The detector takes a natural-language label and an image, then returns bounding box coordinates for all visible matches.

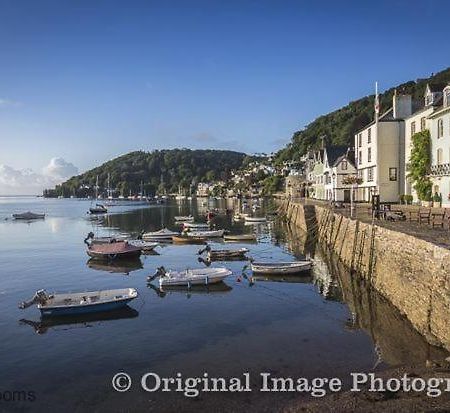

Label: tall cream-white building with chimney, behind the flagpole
[355,93,412,202]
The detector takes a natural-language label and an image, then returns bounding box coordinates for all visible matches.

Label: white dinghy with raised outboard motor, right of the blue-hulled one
[148,267,232,288]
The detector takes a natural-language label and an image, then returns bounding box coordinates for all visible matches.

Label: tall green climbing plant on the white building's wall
[408,130,432,201]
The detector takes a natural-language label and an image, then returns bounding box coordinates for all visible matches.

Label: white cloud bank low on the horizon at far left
[0,158,78,195]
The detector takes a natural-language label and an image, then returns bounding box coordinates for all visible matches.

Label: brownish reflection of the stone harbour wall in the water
[278,220,448,368]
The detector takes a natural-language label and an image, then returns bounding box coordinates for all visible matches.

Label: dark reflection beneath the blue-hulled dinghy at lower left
[20,306,139,334]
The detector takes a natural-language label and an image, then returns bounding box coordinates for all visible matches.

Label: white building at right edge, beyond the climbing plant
[429,85,450,207]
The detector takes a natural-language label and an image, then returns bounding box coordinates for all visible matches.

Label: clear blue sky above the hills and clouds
[0,0,450,193]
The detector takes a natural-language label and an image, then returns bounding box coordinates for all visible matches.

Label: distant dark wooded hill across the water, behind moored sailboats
[44,149,249,197]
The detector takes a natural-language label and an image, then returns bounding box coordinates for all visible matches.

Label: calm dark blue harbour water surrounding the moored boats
[0,198,443,412]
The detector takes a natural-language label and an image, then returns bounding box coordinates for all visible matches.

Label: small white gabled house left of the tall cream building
[323,146,357,202]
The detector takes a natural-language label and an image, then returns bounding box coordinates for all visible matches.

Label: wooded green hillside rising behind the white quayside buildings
[277,68,450,162]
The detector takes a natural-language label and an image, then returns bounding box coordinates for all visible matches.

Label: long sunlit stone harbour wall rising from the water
[280,201,450,350]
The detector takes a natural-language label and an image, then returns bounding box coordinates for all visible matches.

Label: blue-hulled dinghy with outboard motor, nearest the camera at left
[19,288,138,316]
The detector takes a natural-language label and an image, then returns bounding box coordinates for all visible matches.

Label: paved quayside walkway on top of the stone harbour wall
[292,199,450,249]
